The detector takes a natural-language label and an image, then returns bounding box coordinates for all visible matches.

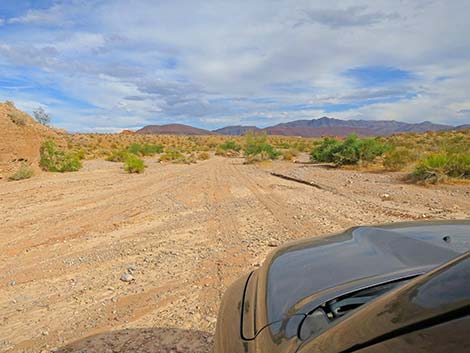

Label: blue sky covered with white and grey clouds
[0,0,470,132]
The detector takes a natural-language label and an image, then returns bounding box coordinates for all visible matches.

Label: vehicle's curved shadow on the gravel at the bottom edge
[56,328,213,353]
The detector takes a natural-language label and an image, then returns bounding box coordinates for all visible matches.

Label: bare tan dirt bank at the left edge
[0,103,61,179]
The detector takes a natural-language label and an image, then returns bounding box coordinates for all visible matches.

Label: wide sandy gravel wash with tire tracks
[0,157,470,353]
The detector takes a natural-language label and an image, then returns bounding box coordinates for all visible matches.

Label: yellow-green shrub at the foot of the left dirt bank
[39,140,82,173]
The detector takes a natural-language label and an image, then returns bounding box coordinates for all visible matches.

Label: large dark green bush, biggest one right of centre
[311,134,390,165]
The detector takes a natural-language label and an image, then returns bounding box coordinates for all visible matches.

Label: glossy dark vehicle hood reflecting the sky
[252,221,470,336]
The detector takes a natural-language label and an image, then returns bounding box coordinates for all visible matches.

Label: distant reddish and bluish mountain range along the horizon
[137,117,470,137]
